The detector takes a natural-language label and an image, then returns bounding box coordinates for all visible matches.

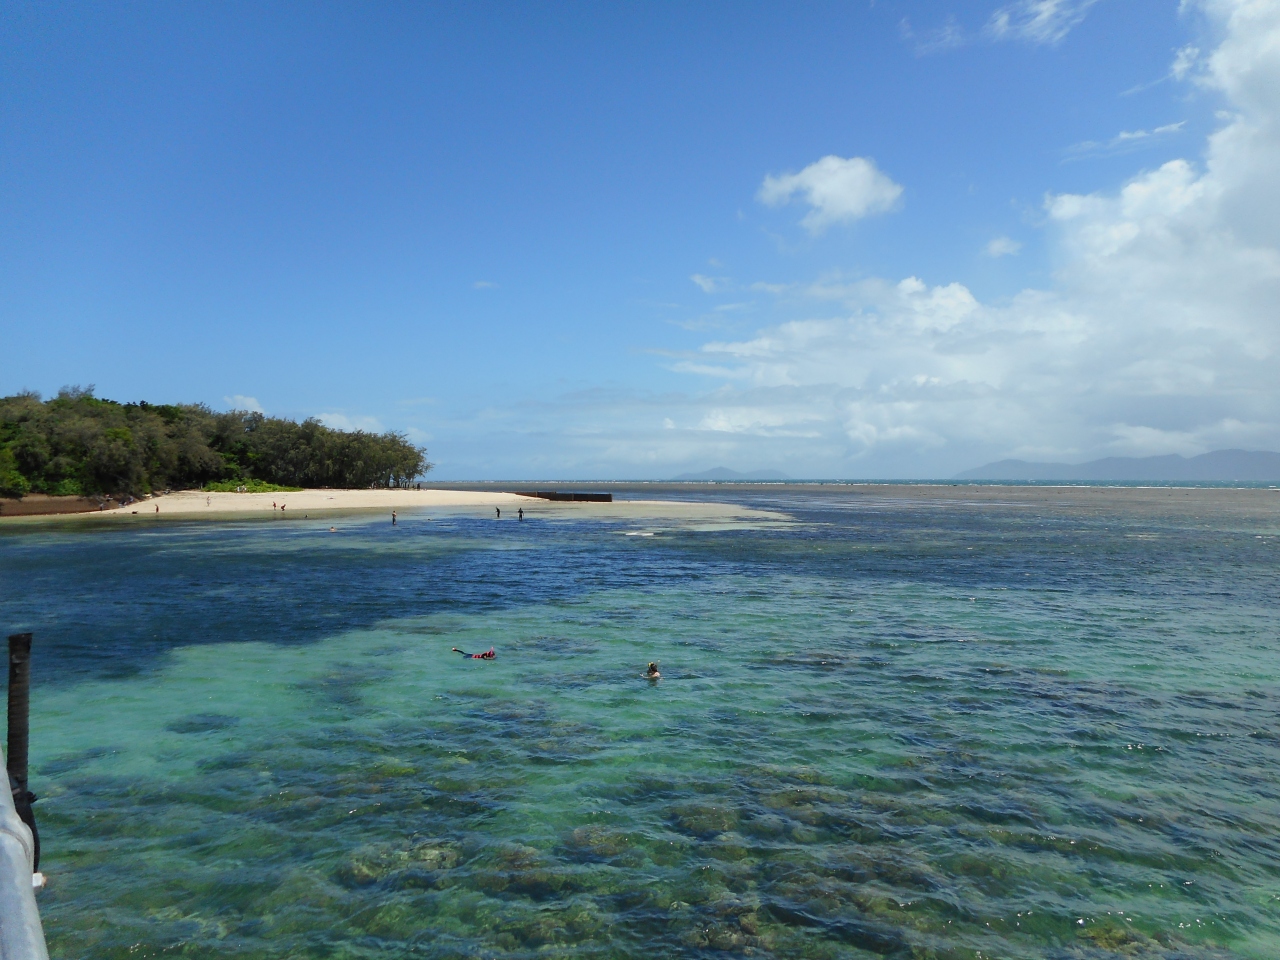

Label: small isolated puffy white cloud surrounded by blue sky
[759,156,902,234]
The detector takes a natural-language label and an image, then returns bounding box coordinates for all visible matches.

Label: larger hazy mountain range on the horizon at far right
[955,451,1280,483]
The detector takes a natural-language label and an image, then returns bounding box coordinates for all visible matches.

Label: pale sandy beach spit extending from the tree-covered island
[0,489,788,526]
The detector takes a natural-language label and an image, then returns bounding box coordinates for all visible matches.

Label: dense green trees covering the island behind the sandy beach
[0,387,431,497]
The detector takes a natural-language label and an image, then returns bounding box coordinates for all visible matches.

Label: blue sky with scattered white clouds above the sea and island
[0,0,1280,479]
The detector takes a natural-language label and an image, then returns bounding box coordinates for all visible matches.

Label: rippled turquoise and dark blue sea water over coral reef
[0,492,1280,957]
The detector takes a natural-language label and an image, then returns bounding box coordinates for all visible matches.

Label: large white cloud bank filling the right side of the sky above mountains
[680,0,1280,474]
